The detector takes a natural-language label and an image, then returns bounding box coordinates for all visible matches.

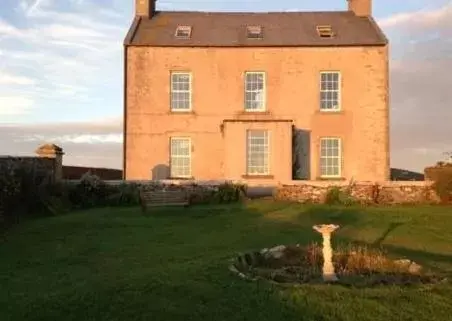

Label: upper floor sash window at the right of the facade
[320,71,341,111]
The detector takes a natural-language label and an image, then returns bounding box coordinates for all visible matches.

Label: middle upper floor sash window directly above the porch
[245,71,265,111]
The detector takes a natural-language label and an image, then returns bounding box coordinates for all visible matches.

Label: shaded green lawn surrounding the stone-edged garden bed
[0,201,452,321]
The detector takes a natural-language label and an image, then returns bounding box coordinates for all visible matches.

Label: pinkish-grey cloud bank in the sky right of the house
[379,3,452,170]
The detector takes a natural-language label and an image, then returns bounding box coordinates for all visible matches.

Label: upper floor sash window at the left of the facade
[171,72,191,112]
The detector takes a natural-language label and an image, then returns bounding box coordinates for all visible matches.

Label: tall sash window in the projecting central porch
[246,130,269,175]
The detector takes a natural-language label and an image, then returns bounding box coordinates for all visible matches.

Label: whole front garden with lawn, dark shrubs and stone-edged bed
[0,159,452,321]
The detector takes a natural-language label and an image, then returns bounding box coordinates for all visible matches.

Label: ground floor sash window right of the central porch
[320,137,341,177]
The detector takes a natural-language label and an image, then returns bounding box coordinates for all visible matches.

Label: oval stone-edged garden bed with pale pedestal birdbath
[229,225,447,287]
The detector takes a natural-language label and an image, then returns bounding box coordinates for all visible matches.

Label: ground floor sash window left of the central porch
[170,137,191,178]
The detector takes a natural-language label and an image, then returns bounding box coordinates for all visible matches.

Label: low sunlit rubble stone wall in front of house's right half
[274,181,439,205]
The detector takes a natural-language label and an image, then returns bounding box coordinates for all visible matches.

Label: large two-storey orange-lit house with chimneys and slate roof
[124,0,390,184]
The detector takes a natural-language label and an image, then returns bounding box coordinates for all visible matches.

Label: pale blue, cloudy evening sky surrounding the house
[0,0,452,171]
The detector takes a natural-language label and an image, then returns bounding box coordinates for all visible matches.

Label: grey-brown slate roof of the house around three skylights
[124,11,388,47]
